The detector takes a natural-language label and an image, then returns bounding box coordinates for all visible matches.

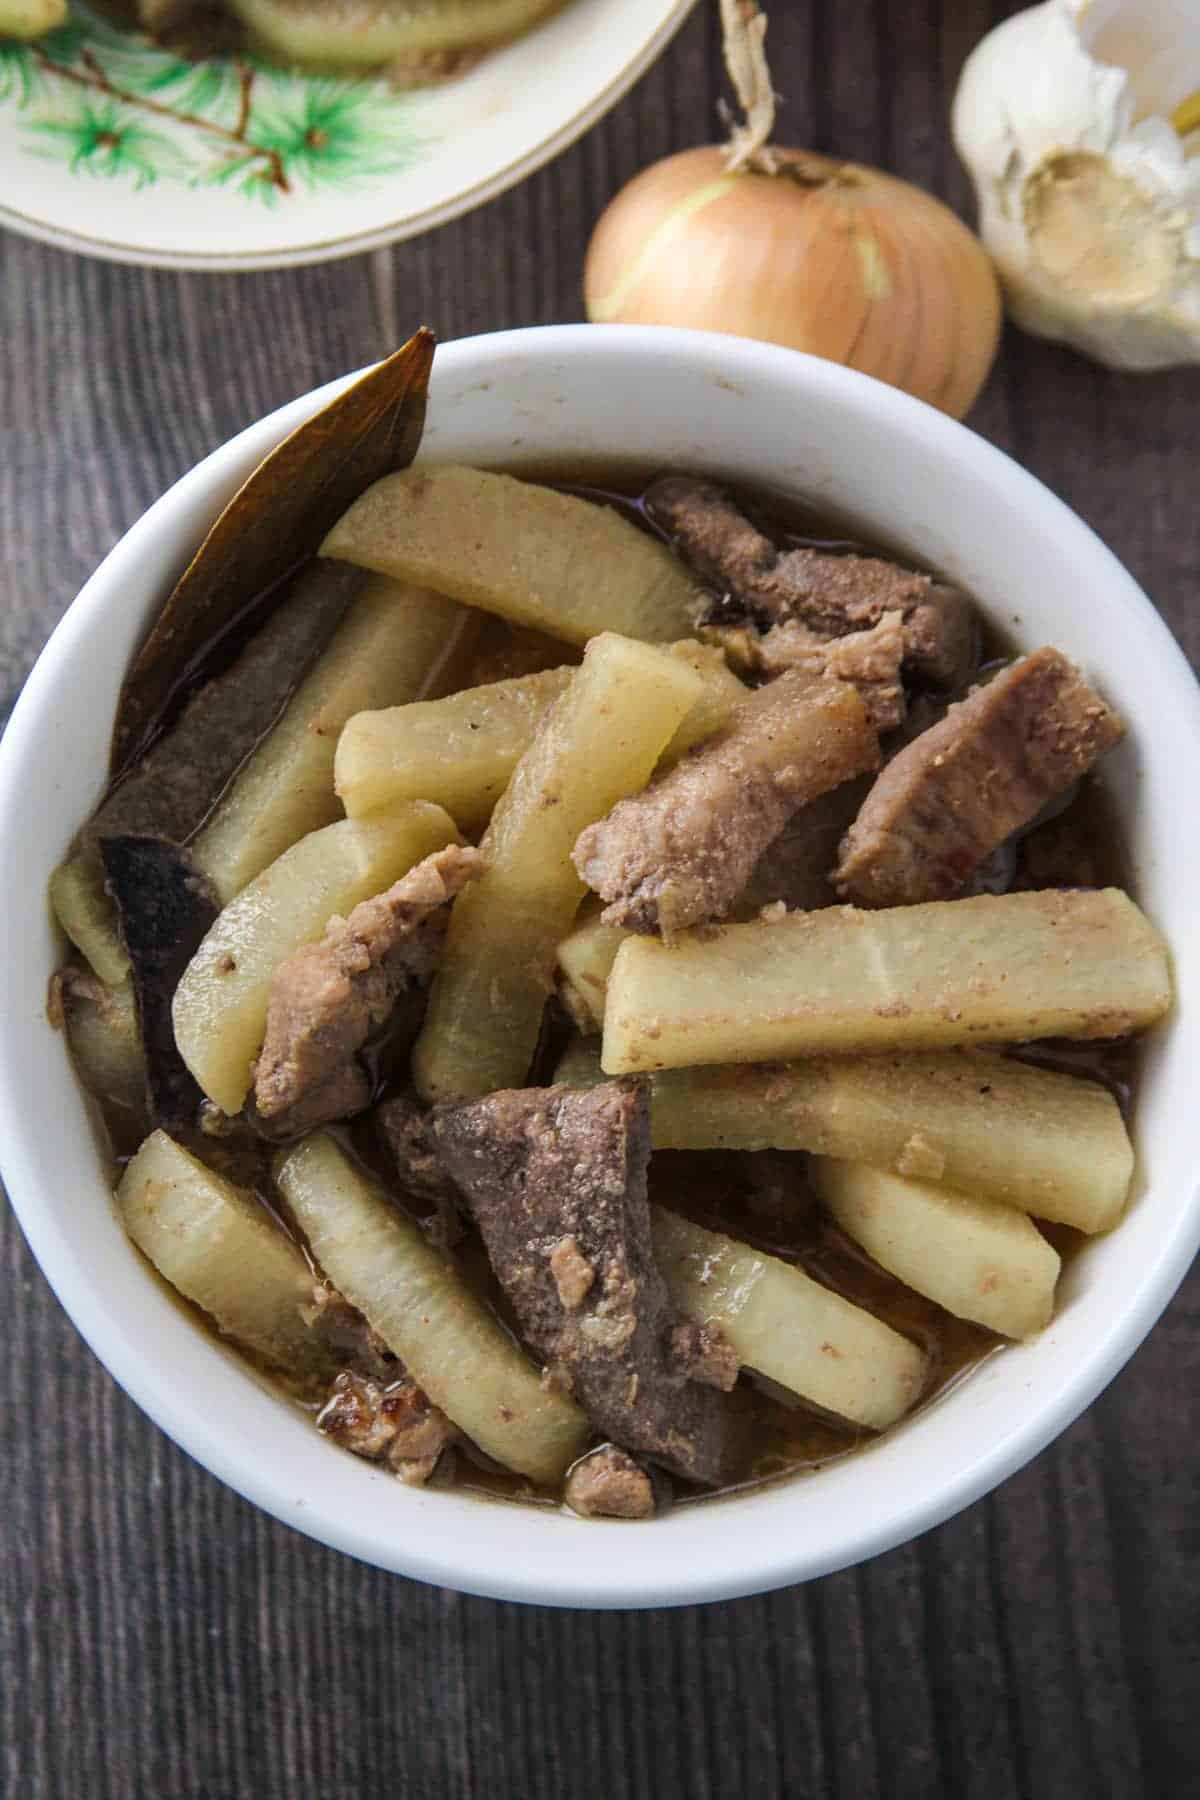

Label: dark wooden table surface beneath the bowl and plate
[0,0,1200,1800]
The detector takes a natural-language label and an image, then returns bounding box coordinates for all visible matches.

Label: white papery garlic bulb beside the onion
[954,0,1200,369]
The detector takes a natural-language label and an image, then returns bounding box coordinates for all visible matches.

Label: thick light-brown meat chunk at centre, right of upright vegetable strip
[574,670,880,938]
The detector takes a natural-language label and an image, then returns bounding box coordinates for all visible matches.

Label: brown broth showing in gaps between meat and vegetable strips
[75,466,1139,1507]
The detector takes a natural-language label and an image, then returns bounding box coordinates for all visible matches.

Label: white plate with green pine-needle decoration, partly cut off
[0,0,694,270]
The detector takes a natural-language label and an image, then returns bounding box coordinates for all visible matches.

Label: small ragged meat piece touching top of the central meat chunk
[703,612,907,731]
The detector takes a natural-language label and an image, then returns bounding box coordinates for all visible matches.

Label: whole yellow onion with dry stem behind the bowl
[583,0,1000,418]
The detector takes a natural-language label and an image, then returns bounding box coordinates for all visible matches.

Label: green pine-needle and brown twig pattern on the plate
[0,5,428,207]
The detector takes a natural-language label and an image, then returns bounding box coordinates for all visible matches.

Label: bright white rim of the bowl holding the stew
[0,326,1200,1607]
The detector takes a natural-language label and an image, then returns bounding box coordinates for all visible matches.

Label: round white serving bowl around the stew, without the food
[0,326,1200,1606]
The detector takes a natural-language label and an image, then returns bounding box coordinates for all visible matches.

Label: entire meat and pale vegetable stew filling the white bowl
[50,342,1171,1528]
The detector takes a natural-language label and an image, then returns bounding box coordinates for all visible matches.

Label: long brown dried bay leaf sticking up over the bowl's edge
[113,328,435,769]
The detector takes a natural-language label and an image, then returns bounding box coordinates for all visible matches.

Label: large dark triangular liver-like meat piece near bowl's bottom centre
[435,1082,725,1483]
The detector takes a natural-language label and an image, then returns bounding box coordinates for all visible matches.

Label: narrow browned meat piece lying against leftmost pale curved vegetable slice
[254,844,484,1136]
